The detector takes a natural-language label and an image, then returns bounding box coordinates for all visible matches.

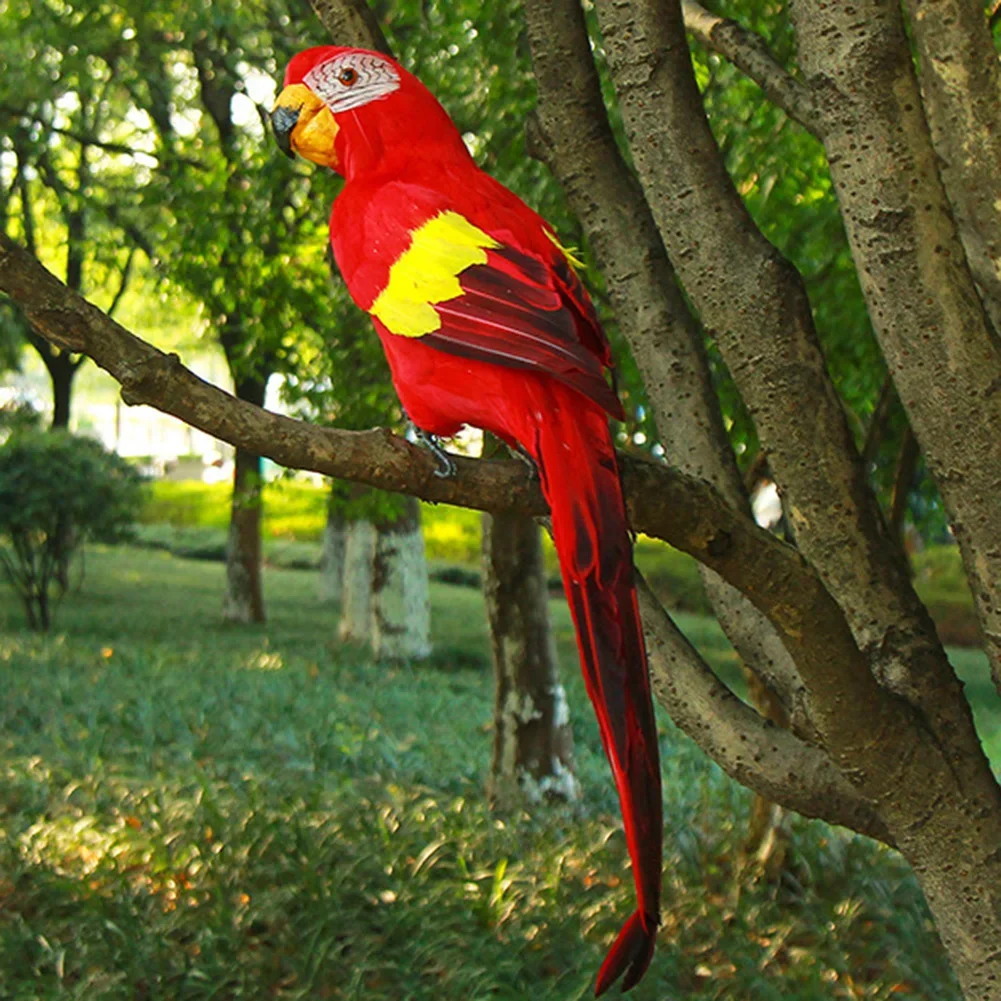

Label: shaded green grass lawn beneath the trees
[0,549,968,1001]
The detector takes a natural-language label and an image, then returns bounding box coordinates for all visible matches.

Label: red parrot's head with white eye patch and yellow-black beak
[271,45,468,177]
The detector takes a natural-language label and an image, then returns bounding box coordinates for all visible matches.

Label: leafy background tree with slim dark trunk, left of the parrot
[115,2,323,622]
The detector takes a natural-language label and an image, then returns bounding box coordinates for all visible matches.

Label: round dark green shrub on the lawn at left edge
[0,430,143,630]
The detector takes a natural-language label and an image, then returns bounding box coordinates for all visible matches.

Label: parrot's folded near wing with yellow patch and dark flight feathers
[344,185,624,420]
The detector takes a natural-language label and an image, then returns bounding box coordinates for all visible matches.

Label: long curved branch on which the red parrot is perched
[0,235,909,771]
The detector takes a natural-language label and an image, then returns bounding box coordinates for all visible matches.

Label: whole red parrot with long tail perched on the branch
[271,46,662,994]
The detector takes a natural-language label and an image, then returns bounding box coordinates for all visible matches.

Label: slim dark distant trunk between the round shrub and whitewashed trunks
[222,376,267,623]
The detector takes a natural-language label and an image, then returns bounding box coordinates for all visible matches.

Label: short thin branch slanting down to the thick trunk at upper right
[682,0,821,136]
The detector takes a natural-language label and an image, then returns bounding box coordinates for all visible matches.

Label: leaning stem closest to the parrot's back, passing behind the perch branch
[525,0,813,748]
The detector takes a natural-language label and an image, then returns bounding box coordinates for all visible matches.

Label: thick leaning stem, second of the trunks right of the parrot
[596,0,972,752]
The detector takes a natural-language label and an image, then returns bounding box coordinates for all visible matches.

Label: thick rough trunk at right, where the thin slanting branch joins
[792,2,1001,704]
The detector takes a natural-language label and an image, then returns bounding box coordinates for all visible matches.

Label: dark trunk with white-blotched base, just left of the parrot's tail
[483,514,580,809]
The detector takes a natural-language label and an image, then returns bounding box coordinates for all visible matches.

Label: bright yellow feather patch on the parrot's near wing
[368,211,501,337]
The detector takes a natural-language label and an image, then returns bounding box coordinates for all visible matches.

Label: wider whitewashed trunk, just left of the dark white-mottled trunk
[372,496,431,661]
